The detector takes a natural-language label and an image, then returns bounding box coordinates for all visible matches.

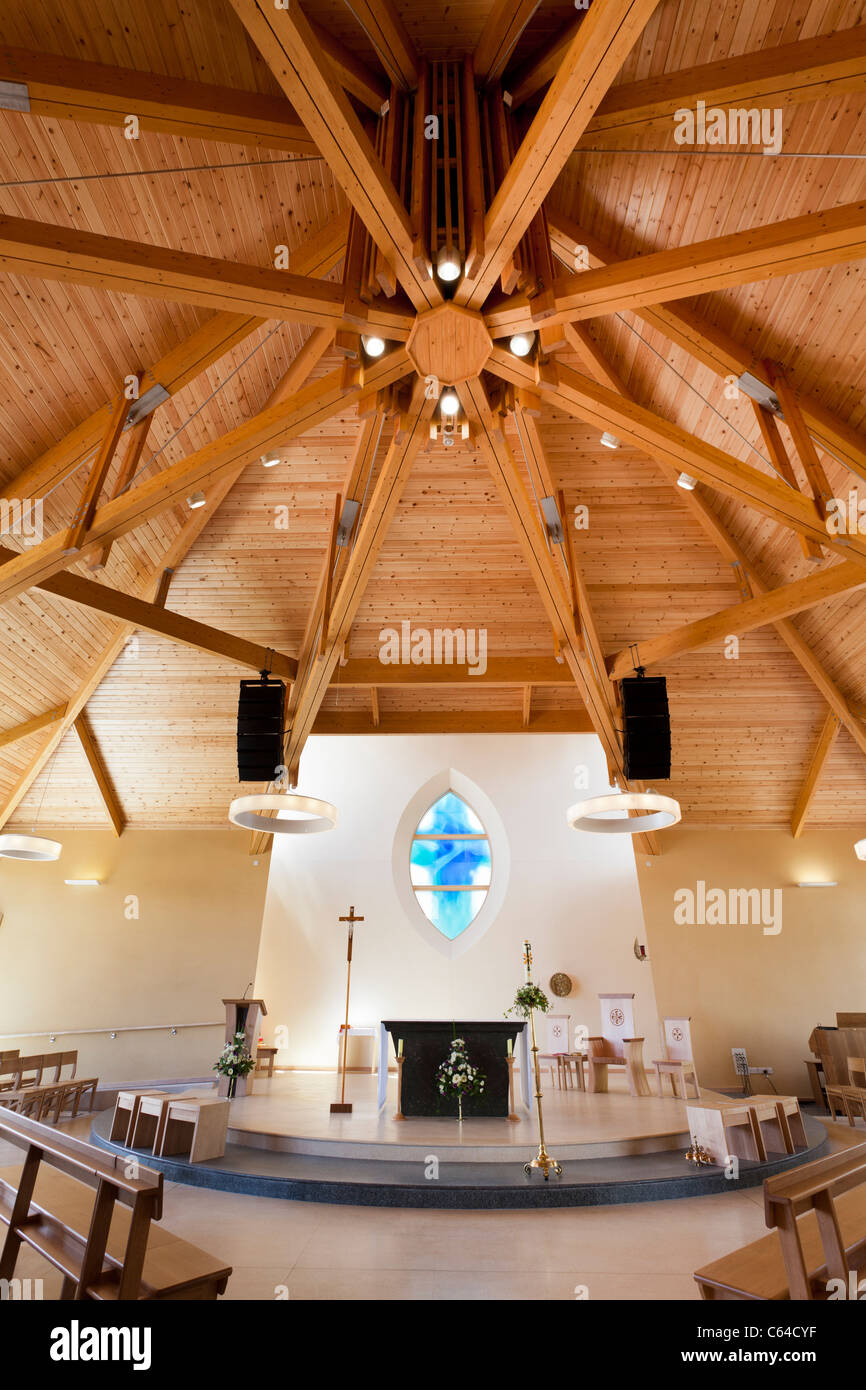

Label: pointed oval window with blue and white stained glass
[409,791,492,941]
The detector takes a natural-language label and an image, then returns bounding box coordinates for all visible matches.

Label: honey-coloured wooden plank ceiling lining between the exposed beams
[0,0,866,831]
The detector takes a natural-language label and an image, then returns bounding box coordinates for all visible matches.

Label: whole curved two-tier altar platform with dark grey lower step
[92,1072,827,1209]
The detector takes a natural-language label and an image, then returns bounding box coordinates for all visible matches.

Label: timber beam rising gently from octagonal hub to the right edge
[484,202,866,338]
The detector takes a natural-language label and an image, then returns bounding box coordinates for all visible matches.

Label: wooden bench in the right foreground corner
[695,1144,866,1301]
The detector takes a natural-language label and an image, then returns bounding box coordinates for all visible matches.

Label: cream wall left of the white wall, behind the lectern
[0,827,268,1081]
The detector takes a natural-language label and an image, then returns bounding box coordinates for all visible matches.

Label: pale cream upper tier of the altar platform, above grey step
[228,1072,697,1163]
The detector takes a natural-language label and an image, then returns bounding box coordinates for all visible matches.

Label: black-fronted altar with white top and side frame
[378,1019,532,1119]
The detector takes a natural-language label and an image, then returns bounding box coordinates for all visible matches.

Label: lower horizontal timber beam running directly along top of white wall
[311,709,594,733]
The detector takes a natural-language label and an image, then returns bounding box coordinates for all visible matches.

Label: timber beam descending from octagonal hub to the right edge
[487,348,866,560]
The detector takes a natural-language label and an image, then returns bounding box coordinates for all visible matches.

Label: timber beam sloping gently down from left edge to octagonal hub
[0,215,413,342]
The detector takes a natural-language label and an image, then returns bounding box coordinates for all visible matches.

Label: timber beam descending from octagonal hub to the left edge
[0,349,414,602]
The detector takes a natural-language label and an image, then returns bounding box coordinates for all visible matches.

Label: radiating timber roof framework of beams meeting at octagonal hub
[0,0,866,849]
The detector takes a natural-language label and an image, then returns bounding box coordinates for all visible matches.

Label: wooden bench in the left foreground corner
[0,1106,232,1301]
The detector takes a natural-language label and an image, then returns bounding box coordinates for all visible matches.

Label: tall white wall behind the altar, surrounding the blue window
[256,734,657,1066]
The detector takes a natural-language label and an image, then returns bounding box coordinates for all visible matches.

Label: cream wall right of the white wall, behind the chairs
[638,827,866,1095]
